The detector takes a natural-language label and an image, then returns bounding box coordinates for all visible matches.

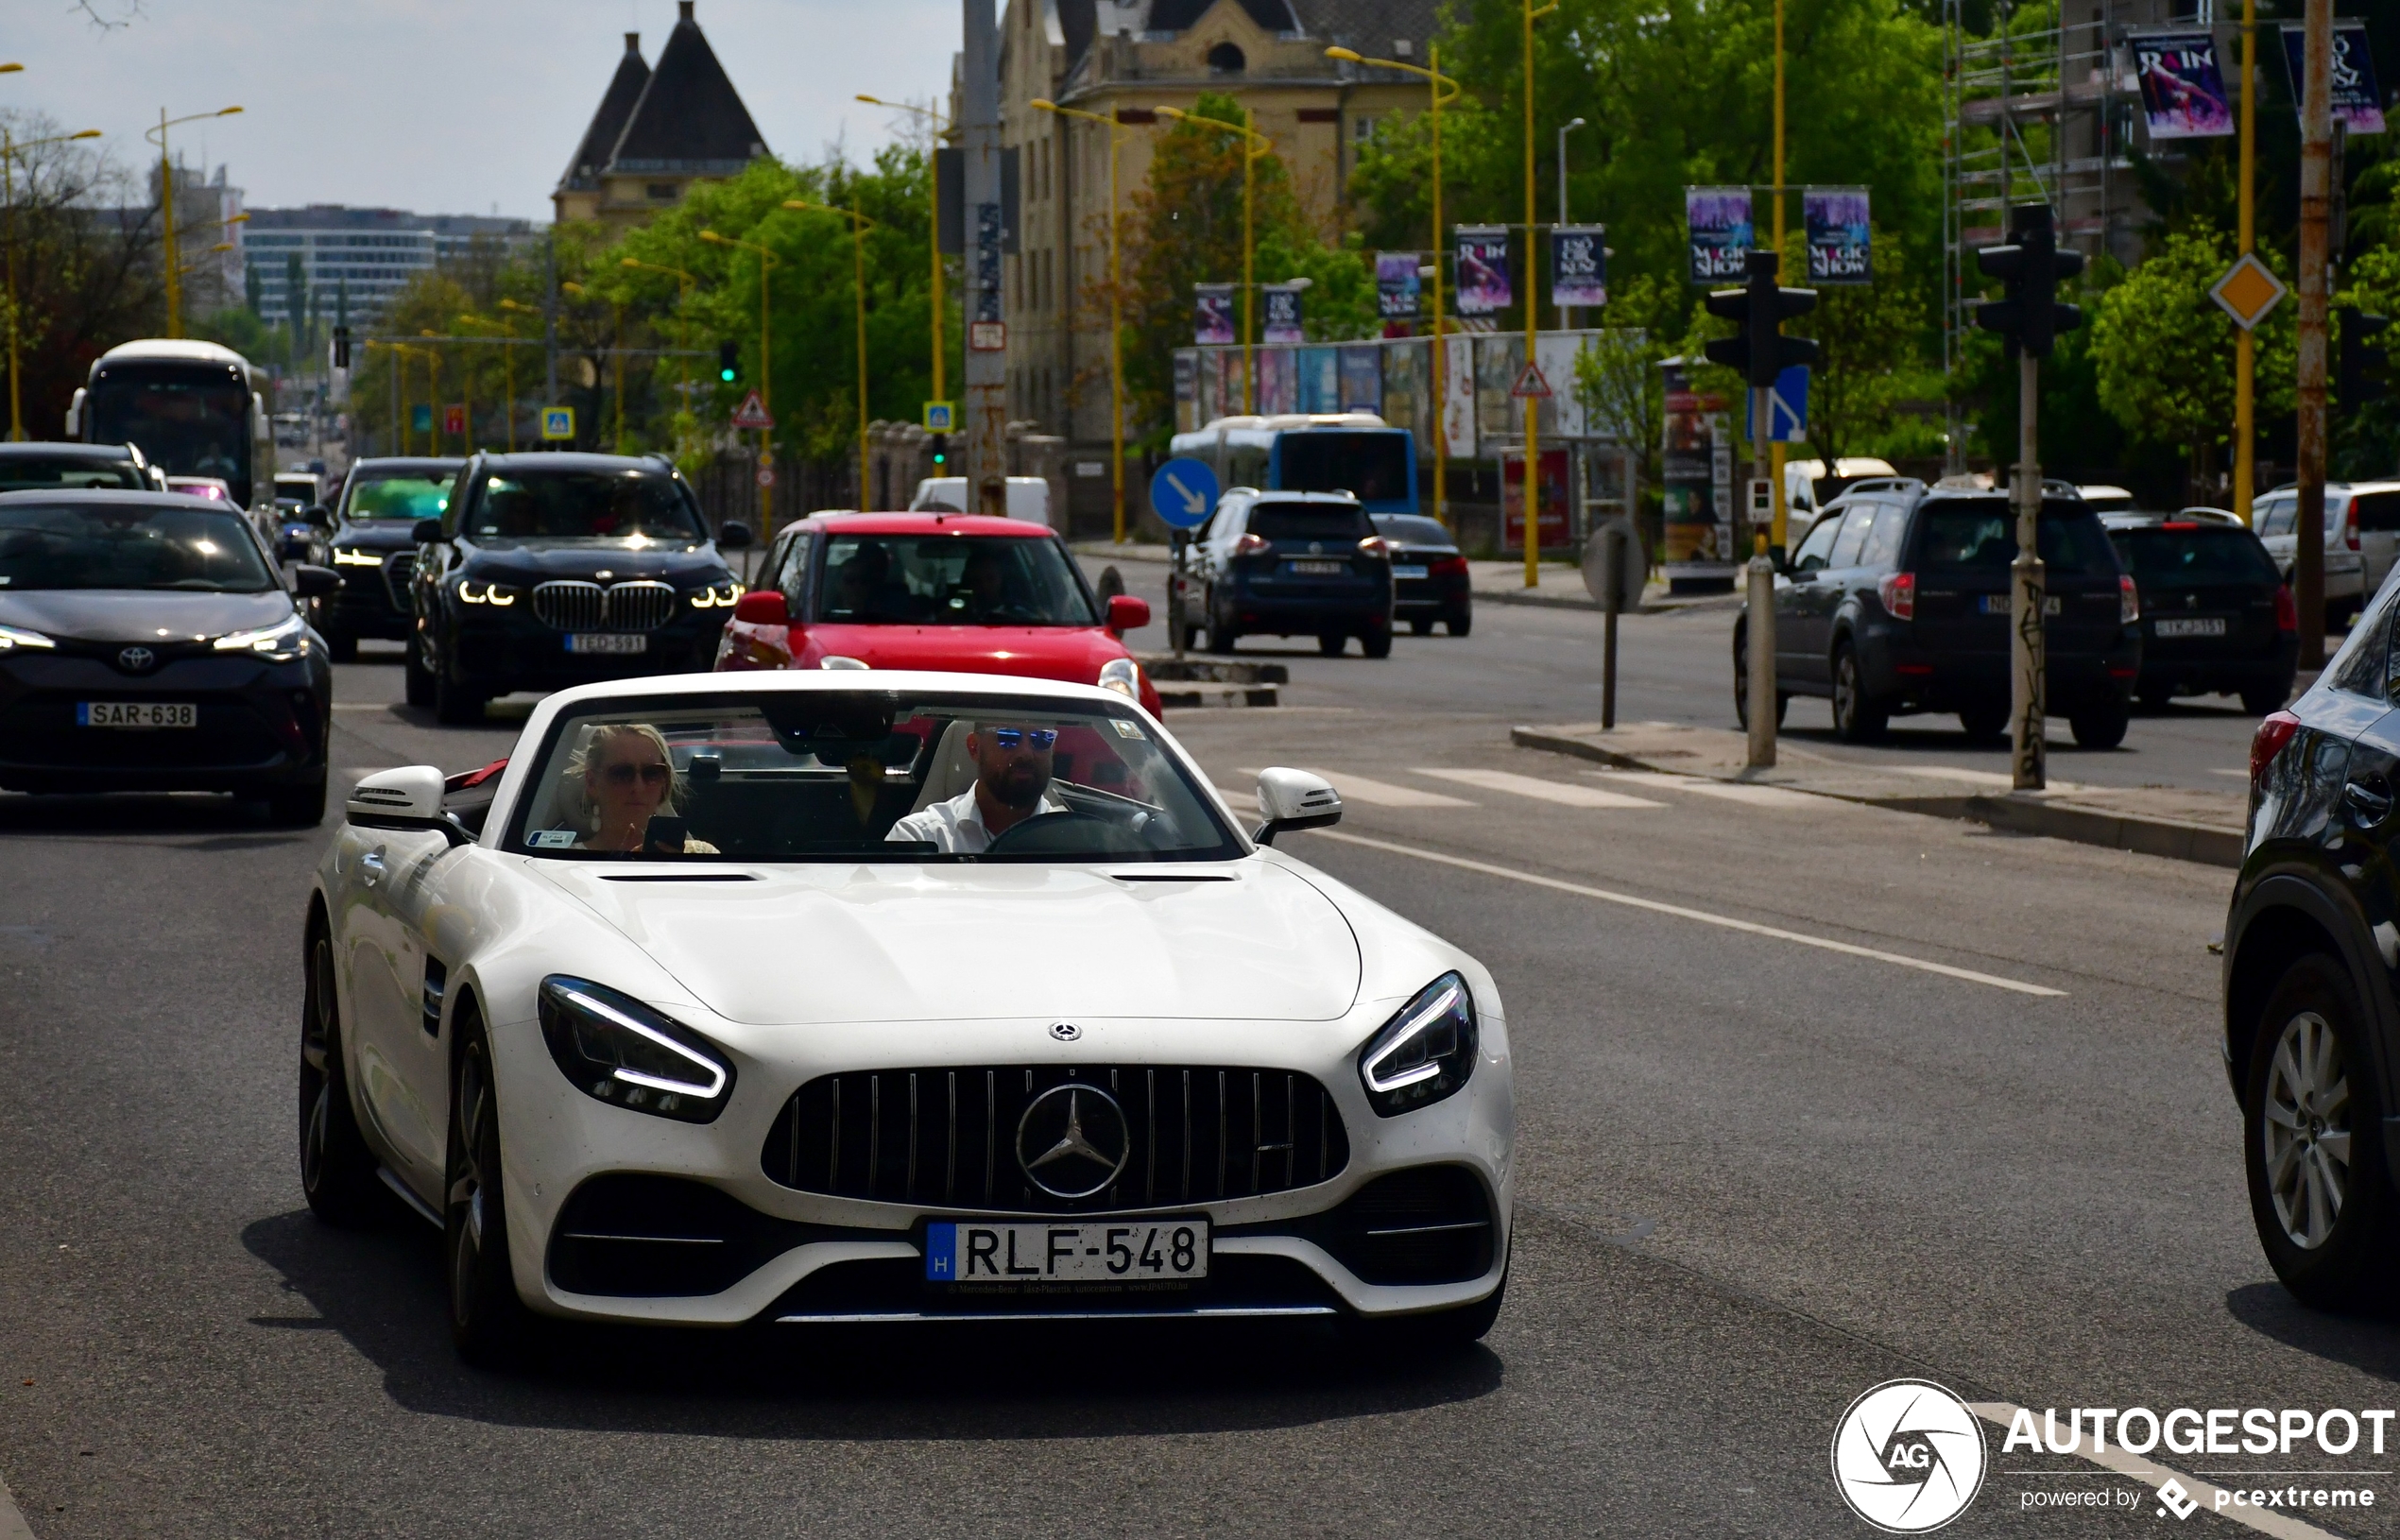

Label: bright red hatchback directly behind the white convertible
[717,513,1159,715]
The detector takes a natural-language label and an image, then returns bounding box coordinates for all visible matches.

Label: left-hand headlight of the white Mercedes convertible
[540,974,734,1122]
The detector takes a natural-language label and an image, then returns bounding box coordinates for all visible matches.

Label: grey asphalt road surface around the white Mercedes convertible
[0,628,2400,1540]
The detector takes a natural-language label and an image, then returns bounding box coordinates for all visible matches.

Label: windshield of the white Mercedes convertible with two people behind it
[506,691,1241,861]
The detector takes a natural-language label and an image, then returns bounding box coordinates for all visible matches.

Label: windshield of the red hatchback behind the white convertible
[816,535,1099,626]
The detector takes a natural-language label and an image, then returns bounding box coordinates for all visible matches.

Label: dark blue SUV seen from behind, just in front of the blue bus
[1169,487,1392,658]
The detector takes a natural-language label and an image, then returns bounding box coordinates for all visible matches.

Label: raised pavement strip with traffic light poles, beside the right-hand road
[1510,722,2249,866]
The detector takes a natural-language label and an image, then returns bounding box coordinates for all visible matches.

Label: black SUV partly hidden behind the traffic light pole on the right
[1733,482,2141,748]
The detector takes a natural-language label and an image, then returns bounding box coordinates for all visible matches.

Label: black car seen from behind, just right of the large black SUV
[2100,513,2299,717]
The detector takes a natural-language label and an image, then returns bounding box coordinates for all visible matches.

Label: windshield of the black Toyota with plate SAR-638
[0,502,276,592]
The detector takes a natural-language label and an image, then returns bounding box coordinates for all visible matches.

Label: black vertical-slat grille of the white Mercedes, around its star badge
[761,1065,1348,1214]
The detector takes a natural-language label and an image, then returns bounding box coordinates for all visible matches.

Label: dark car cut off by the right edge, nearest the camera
[2222,583,2400,1308]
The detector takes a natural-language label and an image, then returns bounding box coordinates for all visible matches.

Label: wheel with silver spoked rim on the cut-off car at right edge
[2241,952,2400,1309]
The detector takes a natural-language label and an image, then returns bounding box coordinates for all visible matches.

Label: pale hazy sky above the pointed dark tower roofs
[0,0,960,221]
